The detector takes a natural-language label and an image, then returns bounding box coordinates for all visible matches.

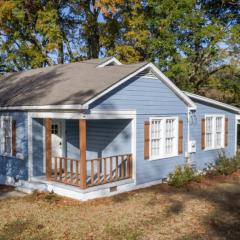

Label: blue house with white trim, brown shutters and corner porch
[0,58,240,200]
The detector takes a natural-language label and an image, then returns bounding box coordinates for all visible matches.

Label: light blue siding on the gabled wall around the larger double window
[90,77,187,184]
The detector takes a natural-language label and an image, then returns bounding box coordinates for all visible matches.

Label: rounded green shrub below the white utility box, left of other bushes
[168,166,198,188]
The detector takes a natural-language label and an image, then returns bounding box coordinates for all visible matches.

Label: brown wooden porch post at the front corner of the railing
[79,119,87,189]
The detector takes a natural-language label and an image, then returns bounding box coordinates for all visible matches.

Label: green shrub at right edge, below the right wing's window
[209,153,240,175]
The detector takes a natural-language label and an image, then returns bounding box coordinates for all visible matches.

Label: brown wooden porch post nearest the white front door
[44,118,52,179]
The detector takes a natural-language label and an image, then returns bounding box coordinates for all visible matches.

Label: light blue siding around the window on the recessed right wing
[190,101,236,169]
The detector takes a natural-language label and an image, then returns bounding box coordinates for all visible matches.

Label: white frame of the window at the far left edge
[0,116,12,156]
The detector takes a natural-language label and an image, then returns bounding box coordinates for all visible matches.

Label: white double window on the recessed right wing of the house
[206,115,224,149]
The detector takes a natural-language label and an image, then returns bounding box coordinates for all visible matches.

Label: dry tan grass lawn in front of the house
[0,173,240,240]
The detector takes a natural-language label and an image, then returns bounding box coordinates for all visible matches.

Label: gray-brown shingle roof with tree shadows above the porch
[0,58,147,107]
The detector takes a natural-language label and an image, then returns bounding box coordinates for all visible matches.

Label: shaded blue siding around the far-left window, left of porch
[0,112,28,183]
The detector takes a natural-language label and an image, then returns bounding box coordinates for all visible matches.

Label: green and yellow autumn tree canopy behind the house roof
[0,0,240,105]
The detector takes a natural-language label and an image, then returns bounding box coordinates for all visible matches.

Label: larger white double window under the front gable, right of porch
[150,117,178,159]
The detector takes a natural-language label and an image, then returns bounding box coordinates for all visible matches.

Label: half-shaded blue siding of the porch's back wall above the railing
[66,119,131,160]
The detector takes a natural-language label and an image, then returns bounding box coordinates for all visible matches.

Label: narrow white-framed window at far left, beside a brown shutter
[1,116,12,155]
